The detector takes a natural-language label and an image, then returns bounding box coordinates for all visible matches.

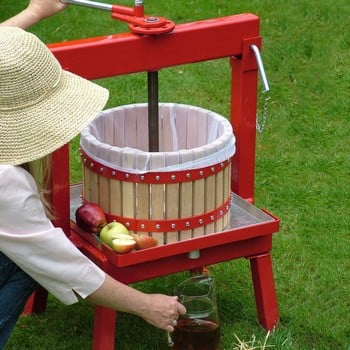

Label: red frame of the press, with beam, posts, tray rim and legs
[26,14,279,350]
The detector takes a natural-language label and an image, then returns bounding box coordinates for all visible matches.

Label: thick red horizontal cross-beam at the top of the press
[49,14,259,79]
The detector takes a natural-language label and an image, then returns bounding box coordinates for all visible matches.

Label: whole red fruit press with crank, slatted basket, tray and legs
[26,0,279,350]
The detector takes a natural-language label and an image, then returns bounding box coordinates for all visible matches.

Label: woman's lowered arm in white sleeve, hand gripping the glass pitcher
[0,165,185,332]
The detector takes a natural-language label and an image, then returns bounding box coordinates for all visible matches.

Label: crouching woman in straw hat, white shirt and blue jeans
[0,6,186,349]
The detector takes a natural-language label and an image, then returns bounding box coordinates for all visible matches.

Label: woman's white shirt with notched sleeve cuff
[0,165,105,304]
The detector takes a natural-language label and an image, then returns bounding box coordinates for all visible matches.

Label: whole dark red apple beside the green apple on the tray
[75,202,107,233]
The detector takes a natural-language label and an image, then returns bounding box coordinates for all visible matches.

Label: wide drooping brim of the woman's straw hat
[0,71,109,165]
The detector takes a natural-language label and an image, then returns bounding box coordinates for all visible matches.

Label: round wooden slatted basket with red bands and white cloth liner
[81,103,235,244]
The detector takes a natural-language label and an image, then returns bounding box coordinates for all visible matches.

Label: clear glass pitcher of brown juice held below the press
[171,275,220,350]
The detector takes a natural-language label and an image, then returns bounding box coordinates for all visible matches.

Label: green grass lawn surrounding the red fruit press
[0,0,350,350]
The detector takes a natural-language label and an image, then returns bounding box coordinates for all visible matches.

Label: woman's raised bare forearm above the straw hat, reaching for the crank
[0,0,67,29]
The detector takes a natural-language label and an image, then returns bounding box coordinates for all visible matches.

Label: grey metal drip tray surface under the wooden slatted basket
[70,184,275,231]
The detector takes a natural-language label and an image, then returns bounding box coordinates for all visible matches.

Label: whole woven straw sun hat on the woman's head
[0,27,108,165]
